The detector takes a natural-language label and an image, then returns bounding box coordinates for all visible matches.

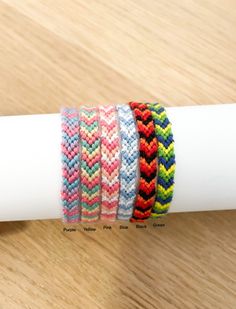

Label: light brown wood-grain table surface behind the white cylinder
[0,0,236,309]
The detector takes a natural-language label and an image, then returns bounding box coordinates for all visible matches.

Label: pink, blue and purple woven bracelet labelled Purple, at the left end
[61,108,80,223]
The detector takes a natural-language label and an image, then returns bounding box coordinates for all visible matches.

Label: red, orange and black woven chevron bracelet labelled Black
[129,102,158,221]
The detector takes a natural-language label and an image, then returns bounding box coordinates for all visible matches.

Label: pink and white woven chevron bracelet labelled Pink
[99,106,120,221]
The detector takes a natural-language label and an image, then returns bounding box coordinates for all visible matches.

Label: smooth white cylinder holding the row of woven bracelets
[0,104,236,221]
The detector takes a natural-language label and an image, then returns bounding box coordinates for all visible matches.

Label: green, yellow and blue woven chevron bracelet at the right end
[148,103,175,218]
